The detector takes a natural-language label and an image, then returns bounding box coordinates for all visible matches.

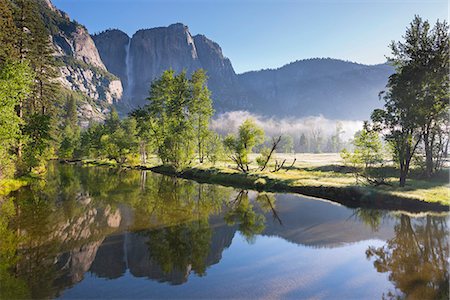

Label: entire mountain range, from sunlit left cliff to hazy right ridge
[39,0,393,122]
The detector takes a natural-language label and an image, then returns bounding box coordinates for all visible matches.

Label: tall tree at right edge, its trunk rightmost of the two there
[391,16,450,177]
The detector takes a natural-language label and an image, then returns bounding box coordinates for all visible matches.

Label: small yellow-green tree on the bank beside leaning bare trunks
[224,119,264,173]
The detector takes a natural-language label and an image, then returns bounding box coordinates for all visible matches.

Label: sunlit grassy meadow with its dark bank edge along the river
[68,154,450,212]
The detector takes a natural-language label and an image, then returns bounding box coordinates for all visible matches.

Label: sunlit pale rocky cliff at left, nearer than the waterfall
[38,0,123,121]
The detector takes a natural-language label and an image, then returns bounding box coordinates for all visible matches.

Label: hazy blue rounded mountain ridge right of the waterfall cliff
[238,58,394,120]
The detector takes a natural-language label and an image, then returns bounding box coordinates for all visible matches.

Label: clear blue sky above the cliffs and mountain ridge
[53,0,449,73]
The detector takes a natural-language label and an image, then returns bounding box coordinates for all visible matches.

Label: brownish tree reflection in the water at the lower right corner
[366,215,449,299]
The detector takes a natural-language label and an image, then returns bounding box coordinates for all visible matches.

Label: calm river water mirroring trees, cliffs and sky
[0,164,449,299]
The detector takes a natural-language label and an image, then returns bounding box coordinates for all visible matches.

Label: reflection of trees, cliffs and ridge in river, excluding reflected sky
[0,164,449,299]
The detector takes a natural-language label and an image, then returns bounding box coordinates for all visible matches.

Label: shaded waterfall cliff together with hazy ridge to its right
[93,23,393,119]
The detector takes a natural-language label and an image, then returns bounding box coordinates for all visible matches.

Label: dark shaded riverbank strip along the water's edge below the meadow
[150,166,449,212]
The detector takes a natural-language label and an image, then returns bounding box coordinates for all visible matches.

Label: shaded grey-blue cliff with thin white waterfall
[93,23,241,108]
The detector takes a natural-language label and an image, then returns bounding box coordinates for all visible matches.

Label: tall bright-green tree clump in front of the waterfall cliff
[132,70,216,169]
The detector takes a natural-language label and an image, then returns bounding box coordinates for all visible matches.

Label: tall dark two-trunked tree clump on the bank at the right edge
[372,16,449,187]
